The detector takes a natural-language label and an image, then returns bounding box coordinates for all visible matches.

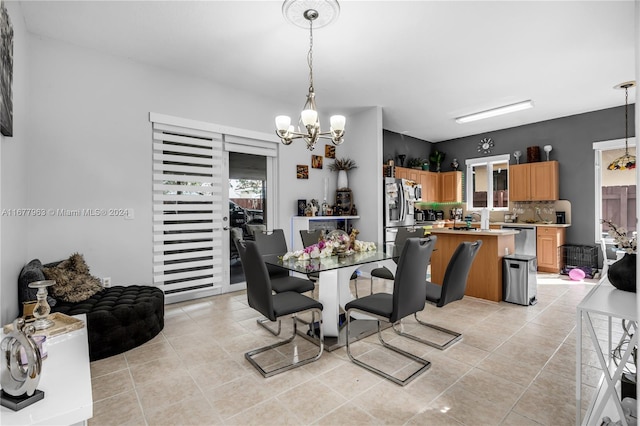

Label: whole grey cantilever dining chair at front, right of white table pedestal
[345,238,435,386]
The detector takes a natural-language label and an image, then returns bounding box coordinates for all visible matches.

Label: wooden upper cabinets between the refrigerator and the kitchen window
[395,167,462,203]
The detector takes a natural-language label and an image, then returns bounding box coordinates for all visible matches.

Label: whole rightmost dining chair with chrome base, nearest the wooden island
[393,240,482,350]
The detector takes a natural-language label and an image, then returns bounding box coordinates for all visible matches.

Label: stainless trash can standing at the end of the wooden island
[502,254,538,306]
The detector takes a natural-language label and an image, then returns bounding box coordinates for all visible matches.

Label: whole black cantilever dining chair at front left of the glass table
[237,241,324,377]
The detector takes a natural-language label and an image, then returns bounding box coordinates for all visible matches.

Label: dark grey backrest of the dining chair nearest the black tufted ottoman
[236,240,276,321]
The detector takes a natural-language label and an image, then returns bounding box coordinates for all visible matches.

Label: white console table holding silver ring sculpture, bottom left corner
[0,315,93,426]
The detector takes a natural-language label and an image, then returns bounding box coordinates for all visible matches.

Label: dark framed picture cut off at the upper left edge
[0,2,13,136]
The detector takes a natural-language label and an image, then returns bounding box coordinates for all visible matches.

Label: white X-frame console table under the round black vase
[576,276,638,425]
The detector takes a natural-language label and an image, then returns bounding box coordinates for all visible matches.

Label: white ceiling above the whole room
[21,0,637,142]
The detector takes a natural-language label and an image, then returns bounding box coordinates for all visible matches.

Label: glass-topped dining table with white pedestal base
[264,250,397,351]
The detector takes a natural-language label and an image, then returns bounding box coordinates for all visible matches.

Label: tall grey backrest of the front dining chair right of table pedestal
[389,236,437,323]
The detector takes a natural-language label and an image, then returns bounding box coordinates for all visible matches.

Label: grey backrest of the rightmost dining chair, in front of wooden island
[436,240,482,307]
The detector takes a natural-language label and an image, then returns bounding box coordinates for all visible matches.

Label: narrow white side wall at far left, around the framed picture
[0,2,31,324]
